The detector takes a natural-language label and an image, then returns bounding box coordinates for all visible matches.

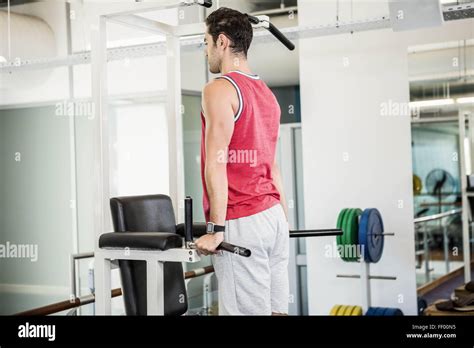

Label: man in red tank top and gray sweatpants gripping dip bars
[196,8,289,315]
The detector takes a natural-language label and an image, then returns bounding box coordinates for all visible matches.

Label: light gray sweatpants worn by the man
[213,204,289,315]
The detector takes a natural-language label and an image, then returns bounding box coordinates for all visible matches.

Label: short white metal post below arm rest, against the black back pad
[146,259,165,315]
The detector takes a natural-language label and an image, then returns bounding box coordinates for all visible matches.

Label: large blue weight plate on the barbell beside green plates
[359,209,384,263]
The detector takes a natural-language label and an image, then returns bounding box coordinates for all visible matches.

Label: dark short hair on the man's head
[206,7,253,57]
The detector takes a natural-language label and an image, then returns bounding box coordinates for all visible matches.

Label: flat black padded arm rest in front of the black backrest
[99,232,183,250]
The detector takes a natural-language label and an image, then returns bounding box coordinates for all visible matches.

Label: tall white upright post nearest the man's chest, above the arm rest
[166,33,184,221]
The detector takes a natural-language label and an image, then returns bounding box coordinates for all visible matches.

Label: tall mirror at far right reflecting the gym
[408,40,474,287]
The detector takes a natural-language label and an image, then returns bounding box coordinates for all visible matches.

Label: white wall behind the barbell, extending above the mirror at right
[299,0,472,314]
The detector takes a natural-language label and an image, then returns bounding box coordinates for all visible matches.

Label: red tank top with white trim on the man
[201,71,281,221]
